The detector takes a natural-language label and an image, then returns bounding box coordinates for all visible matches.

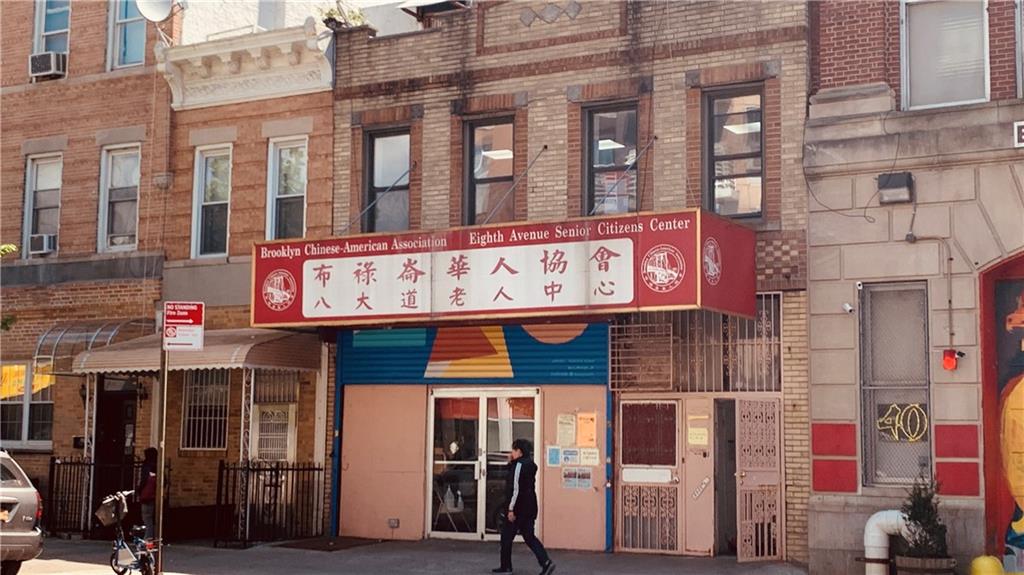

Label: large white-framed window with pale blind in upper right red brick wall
[900,0,988,108]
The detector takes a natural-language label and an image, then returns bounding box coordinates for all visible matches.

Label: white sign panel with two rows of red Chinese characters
[302,238,634,317]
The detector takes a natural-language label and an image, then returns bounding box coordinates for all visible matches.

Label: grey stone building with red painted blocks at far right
[804,0,1024,573]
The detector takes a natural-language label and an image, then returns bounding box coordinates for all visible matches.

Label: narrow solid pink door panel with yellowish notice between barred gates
[680,397,715,556]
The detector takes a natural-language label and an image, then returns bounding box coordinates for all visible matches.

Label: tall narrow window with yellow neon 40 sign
[860,282,932,485]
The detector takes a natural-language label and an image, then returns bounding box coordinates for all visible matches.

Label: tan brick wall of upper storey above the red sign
[325,1,810,562]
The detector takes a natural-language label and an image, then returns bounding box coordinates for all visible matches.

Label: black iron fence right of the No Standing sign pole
[214,460,324,546]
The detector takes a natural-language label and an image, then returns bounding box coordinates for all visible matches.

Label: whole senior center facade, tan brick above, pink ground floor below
[307,2,810,562]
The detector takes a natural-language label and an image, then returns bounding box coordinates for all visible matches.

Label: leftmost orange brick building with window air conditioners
[0,2,178,492]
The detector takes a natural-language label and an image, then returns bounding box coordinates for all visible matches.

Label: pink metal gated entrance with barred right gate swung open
[616,394,782,561]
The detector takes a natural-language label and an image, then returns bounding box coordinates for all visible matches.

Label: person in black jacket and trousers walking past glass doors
[492,439,555,575]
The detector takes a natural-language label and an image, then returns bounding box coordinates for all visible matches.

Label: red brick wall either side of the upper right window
[811,0,1018,102]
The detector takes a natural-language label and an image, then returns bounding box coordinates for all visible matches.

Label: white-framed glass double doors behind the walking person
[427,389,540,539]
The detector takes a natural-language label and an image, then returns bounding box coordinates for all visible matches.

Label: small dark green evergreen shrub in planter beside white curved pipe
[896,478,956,575]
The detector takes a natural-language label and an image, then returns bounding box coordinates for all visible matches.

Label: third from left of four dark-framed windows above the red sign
[586,104,637,215]
